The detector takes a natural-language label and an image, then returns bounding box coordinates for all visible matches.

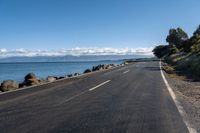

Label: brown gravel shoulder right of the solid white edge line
[165,70,200,133]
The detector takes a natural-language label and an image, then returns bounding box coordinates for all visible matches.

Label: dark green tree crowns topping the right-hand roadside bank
[153,25,200,58]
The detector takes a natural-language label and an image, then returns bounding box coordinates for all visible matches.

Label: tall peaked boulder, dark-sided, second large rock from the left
[20,73,40,87]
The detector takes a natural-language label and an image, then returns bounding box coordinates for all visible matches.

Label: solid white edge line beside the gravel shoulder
[159,60,197,133]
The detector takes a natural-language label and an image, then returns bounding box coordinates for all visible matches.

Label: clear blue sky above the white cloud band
[0,0,200,49]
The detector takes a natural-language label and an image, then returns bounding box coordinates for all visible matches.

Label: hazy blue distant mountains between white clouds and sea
[0,55,151,63]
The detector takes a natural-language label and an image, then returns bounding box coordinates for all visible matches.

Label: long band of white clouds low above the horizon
[0,48,152,58]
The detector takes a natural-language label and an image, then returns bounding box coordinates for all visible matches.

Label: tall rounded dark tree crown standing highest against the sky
[166,28,188,49]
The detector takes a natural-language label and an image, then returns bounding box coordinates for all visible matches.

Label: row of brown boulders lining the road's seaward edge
[0,61,130,93]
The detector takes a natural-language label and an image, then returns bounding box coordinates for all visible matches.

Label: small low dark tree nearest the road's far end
[152,45,169,58]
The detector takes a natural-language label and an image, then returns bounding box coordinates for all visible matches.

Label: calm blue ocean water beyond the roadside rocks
[0,61,122,82]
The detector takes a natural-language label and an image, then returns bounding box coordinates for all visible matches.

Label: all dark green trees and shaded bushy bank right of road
[153,25,200,80]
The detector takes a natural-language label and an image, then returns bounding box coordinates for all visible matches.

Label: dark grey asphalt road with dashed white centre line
[0,62,188,133]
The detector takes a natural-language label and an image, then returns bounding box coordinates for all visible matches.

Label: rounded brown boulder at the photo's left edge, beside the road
[0,80,19,92]
